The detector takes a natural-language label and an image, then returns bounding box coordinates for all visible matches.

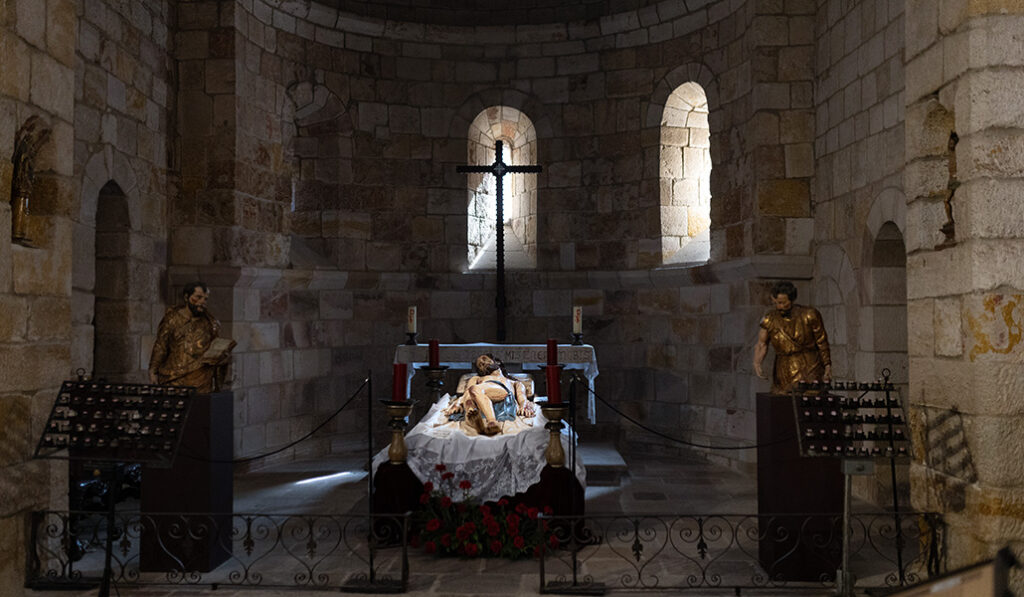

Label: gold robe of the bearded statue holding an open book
[150,306,220,394]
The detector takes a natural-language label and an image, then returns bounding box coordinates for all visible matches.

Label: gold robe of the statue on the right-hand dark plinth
[761,305,831,394]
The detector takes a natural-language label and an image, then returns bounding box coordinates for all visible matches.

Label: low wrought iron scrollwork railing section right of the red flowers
[540,512,943,594]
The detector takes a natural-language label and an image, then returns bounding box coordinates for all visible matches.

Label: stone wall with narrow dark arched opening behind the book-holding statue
[71,1,176,382]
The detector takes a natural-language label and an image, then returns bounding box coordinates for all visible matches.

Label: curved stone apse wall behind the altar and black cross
[197,0,815,477]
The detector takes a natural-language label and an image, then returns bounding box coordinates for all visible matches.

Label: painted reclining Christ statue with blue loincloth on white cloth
[441,354,536,435]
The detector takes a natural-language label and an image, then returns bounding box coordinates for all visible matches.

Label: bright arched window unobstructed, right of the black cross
[659,82,711,263]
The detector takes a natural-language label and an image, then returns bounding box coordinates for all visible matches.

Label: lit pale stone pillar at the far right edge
[905,1,1024,577]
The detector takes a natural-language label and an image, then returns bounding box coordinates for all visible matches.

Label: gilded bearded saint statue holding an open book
[150,282,234,394]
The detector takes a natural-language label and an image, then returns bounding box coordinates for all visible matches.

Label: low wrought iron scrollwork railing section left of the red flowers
[26,511,409,593]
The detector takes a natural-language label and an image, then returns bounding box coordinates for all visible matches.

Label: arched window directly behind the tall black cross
[466,105,537,270]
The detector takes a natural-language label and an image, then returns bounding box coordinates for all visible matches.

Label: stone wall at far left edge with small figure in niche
[0,0,77,594]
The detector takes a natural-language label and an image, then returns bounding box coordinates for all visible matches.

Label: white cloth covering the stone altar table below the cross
[394,342,598,424]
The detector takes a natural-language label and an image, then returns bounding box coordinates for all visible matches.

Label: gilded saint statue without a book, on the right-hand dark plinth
[754,281,831,394]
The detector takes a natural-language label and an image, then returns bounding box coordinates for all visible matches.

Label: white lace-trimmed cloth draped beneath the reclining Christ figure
[374,394,587,502]
